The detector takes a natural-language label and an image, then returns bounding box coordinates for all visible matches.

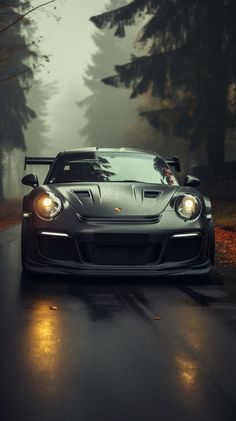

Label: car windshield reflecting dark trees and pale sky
[46,152,178,185]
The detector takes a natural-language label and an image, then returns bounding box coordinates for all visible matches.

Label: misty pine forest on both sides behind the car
[0,0,236,201]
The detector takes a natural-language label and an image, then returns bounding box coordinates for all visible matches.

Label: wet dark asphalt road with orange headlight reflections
[0,226,236,421]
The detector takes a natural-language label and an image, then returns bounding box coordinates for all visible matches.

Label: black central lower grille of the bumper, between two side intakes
[80,238,161,266]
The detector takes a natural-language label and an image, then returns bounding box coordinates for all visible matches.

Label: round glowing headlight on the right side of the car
[175,194,201,220]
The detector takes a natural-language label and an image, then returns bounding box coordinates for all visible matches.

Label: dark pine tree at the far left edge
[0,2,35,201]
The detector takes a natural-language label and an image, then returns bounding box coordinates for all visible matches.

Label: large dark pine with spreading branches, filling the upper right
[91,0,236,173]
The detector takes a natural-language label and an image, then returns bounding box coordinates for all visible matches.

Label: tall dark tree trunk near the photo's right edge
[206,0,227,176]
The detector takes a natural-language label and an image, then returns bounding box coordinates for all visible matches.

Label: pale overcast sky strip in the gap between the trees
[31,0,110,148]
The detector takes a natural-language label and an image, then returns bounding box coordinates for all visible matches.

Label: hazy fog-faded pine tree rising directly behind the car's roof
[78,0,138,147]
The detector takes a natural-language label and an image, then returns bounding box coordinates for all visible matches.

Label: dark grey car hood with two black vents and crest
[50,183,179,218]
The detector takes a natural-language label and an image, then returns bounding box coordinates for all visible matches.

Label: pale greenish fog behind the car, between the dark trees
[3,0,236,197]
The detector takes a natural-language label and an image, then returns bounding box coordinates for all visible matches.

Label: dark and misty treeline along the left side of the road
[0,0,53,202]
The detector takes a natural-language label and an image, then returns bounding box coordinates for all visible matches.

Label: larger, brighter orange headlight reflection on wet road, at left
[26,301,61,386]
